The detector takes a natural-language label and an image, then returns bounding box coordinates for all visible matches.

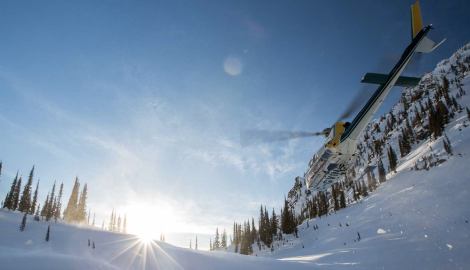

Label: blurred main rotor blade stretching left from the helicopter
[240,129,324,147]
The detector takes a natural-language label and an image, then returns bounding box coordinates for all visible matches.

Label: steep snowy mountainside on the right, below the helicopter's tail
[246,42,470,269]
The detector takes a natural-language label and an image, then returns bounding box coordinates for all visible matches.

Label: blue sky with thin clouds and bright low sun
[0,1,470,247]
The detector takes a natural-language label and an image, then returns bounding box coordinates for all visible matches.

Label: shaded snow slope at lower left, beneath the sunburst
[0,210,324,270]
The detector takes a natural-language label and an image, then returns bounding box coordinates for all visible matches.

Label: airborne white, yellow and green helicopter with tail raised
[240,1,445,191]
